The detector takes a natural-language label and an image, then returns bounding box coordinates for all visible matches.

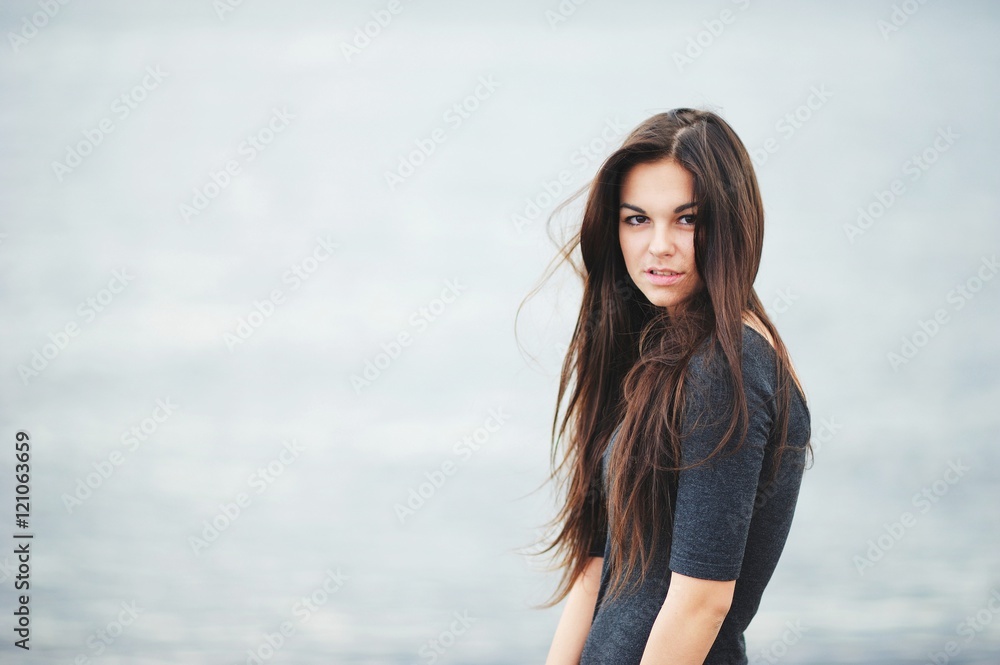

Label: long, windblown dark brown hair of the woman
[515,108,797,607]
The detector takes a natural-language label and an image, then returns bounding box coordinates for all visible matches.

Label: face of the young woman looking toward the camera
[618,159,702,315]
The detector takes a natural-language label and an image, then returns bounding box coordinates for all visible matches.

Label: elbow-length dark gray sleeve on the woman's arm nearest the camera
[670,342,773,580]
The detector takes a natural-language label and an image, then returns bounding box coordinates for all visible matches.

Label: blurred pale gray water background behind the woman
[0,0,1000,665]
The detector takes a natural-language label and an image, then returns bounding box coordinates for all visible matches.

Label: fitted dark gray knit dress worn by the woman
[580,325,811,665]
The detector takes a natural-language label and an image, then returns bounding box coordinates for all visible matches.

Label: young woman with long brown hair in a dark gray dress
[524,108,811,665]
